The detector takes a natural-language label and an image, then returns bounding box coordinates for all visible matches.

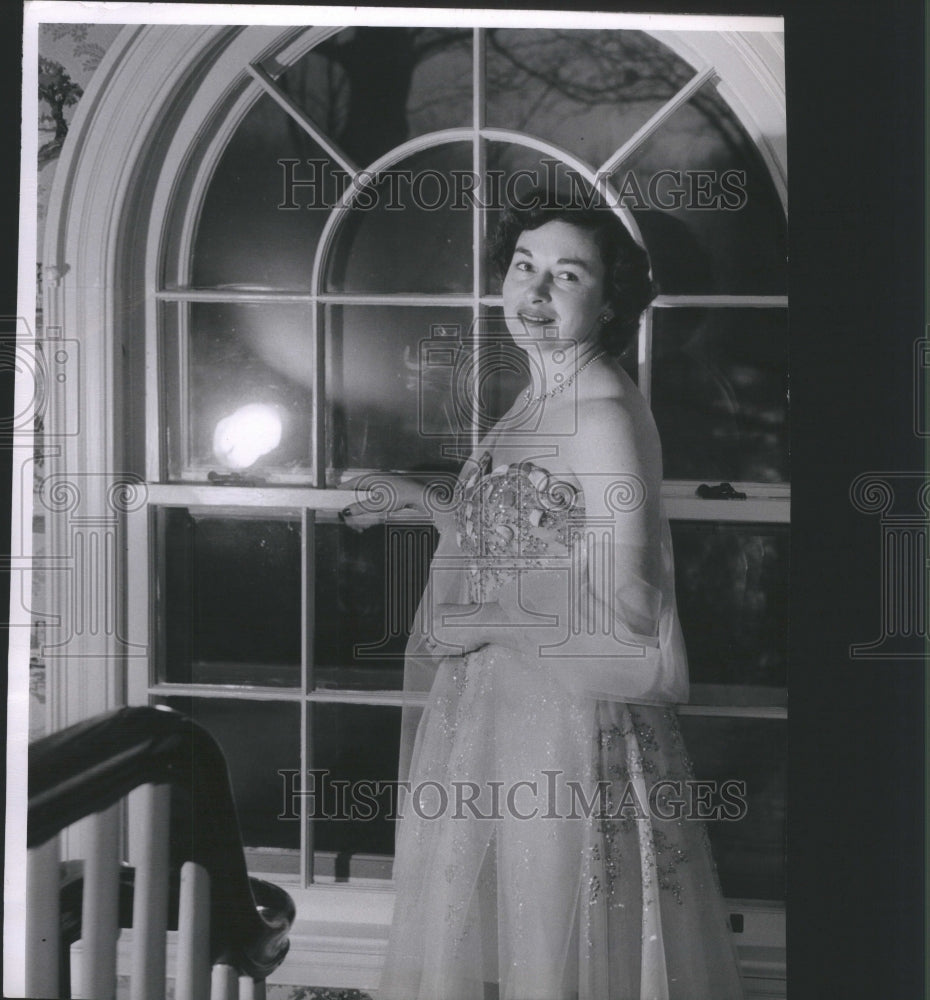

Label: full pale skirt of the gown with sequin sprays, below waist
[377,646,743,1000]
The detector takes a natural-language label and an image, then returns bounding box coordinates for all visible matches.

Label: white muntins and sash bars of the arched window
[145,21,790,885]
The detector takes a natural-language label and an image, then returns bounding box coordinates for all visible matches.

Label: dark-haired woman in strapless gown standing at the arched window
[344,192,742,1000]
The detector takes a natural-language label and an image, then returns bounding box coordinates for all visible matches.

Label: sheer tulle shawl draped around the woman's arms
[399,458,688,781]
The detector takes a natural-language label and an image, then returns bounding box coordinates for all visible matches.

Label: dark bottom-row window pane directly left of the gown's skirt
[308,704,400,880]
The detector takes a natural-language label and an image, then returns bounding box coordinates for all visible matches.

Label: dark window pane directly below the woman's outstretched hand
[313,515,436,690]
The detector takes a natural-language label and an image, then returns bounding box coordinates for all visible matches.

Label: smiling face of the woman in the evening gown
[503,219,608,348]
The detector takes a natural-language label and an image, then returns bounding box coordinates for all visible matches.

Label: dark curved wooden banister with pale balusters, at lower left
[27,707,295,1000]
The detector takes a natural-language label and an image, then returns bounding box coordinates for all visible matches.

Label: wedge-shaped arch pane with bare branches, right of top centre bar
[487,28,695,169]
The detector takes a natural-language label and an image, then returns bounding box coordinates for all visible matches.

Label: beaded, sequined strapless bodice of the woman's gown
[455,452,584,603]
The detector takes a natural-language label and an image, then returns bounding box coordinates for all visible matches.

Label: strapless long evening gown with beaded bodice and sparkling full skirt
[375,452,743,1000]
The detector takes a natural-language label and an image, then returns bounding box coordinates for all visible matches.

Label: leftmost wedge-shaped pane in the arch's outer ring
[188,95,347,291]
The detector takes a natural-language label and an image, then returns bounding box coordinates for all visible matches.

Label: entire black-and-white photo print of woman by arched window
[3,0,930,1000]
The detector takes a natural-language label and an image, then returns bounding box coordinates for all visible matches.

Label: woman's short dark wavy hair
[488,189,656,356]
